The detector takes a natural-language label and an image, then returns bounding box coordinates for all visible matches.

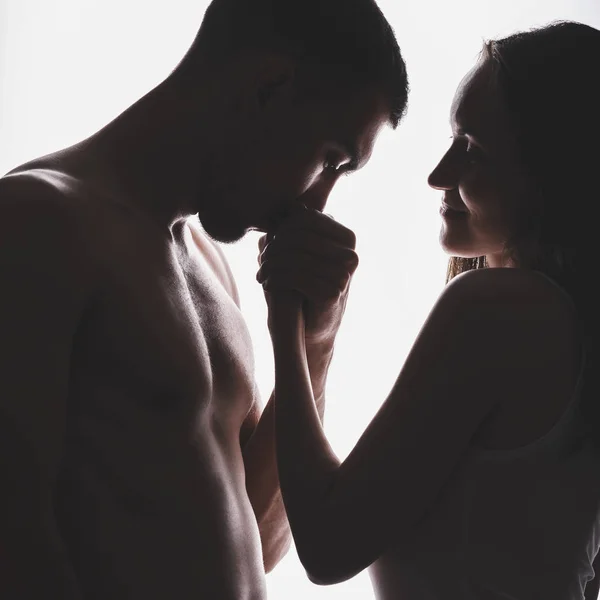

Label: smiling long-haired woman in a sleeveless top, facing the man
[261,22,600,600]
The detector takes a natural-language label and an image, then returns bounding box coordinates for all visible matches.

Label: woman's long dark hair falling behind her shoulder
[448,21,600,446]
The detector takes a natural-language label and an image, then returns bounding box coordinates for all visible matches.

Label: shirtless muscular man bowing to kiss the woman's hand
[0,0,406,600]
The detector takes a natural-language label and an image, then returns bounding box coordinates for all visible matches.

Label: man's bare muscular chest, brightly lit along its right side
[75,234,254,430]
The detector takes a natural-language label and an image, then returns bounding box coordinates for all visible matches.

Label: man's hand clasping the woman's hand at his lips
[256,203,358,353]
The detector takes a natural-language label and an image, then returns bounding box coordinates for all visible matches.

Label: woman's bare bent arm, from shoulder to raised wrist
[271,273,572,584]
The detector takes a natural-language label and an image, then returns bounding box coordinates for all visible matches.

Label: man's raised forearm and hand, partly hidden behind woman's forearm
[245,204,358,565]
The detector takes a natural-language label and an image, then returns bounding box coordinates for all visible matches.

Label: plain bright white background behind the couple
[0,0,600,600]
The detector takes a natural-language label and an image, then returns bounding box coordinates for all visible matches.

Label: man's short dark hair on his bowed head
[180,0,408,127]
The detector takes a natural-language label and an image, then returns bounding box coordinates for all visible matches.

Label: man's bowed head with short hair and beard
[171,0,408,241]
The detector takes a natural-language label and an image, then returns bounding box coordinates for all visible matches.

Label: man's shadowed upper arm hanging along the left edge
[0,176,92,600]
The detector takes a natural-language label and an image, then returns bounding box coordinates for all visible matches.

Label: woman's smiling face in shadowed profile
[429,62,531,266]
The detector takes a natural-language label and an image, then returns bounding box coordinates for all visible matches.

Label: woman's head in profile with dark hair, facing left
[430,22,600,280]
